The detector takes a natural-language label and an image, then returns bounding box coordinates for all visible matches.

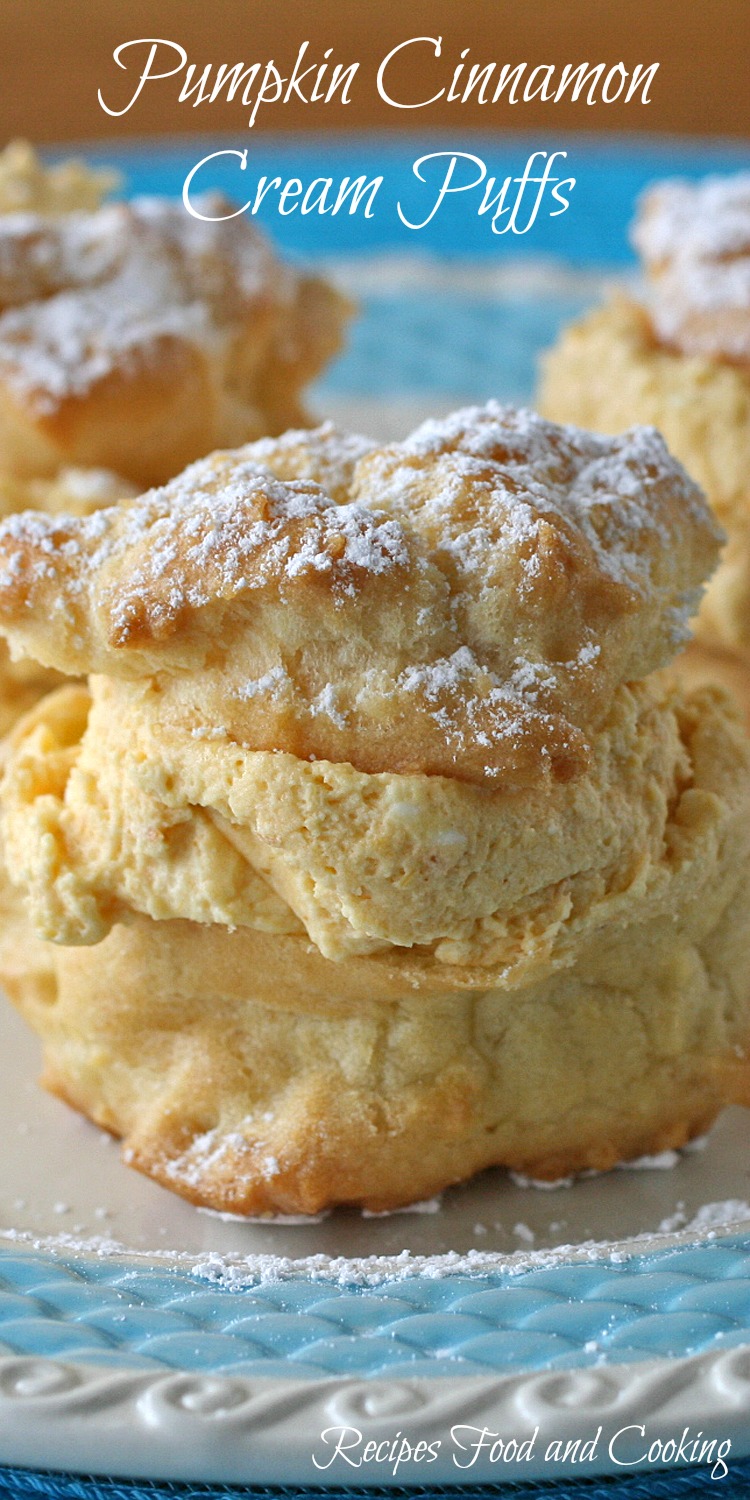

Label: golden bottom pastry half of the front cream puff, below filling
[0,834,750,1215]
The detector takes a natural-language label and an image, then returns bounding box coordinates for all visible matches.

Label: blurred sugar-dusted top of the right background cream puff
[633,173,750,365]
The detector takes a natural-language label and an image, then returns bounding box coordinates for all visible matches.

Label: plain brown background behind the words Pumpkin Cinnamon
[0,0,750,141]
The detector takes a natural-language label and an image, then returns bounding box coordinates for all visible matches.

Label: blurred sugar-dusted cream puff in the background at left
[0,144,351,486]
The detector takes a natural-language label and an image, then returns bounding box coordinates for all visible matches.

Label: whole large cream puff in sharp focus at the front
[0,404,750,1214]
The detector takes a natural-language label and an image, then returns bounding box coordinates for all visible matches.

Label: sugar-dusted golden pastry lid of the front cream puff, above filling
[0,402,720,789]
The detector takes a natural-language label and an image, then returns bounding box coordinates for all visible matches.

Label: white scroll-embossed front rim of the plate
[0,1344,750,1487]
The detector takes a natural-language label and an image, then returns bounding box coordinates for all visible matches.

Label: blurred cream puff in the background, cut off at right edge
[540,174,750,662]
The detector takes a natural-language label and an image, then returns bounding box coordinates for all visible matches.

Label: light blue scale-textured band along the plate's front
[0,1235,750,1380]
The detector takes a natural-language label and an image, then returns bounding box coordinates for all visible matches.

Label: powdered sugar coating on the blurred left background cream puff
[0,197,288,413]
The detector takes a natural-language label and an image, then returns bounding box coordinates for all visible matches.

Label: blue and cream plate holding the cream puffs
[0,137,750,1485]
